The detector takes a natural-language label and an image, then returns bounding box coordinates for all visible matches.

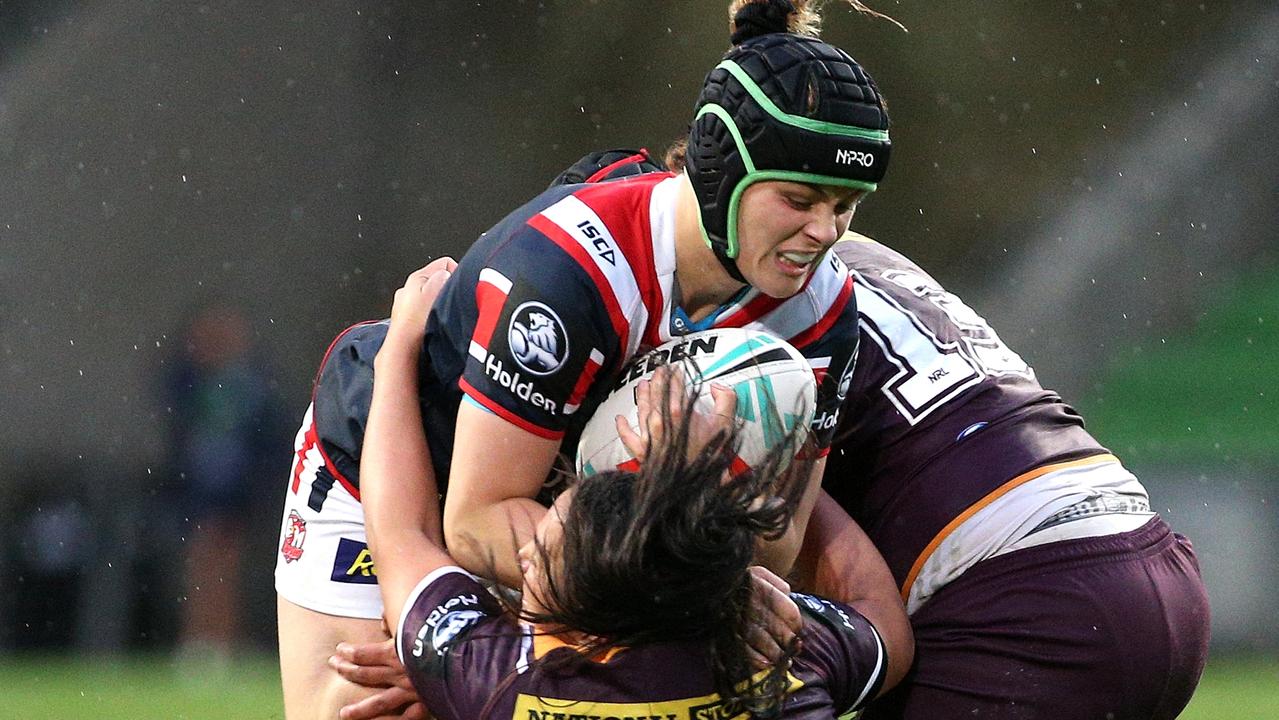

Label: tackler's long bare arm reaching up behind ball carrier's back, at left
[359,258,453,632]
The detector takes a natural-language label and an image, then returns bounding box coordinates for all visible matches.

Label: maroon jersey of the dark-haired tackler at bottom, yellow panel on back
[396,568,886,720]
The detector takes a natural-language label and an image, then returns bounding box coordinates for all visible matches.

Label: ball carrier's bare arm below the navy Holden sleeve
[444,402,559,587]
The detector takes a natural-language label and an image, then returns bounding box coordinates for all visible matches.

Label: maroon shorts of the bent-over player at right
[863,517,1209,720]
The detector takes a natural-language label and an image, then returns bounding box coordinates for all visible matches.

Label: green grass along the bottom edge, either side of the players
[0,656,1279,720]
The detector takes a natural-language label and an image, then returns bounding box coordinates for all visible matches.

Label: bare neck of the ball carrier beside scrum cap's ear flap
[675,175,746,321]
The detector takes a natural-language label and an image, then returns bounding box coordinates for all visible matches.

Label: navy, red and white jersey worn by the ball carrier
[427,173,857,448]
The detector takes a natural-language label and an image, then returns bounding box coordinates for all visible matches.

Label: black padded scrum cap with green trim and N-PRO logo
[686,33,891,281]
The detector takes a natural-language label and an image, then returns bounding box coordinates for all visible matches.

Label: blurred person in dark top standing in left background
[165,301,286,668]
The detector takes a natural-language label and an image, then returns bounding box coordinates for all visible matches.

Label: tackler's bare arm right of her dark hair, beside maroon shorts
[797,492,914,694]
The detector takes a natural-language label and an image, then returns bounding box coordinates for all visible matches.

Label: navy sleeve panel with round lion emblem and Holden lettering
[427,188,619,439]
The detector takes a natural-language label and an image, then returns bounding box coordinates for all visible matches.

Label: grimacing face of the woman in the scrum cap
[737,180,863,298]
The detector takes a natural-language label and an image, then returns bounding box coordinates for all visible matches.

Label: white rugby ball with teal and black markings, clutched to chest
[577,327,817,477]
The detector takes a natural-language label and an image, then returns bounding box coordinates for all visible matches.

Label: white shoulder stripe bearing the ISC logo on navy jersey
[541,196,648,358]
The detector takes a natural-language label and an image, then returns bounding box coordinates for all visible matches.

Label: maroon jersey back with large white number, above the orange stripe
[824,234,1106,586]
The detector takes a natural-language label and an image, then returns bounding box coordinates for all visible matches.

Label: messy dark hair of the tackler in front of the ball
[523,383,811,716]
